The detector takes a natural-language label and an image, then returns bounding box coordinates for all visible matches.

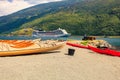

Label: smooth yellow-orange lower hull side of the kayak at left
[0,45,63,56]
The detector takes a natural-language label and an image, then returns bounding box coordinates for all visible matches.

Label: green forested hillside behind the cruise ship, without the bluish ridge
[0,0,120,36]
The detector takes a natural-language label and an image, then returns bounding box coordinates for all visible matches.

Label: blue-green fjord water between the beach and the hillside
[0,36,120,47]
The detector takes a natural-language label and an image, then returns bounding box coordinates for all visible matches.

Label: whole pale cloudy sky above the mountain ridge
[0,0,61,16]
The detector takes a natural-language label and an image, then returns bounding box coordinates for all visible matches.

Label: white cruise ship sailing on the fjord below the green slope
[32,28,70,39]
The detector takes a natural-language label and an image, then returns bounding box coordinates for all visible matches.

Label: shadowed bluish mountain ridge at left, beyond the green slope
[0,2,72,33]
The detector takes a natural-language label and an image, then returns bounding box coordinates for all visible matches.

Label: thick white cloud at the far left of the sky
[0,0,32,16]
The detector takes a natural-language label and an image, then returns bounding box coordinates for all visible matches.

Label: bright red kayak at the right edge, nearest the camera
[88,46,120,56]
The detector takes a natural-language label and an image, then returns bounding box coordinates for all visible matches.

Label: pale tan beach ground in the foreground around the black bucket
[0,45,120,80]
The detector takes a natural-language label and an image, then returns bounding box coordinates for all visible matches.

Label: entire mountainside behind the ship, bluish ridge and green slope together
[0,0,120,35]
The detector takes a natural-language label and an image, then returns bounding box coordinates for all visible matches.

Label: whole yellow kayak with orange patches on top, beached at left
[0,40,64,56]
